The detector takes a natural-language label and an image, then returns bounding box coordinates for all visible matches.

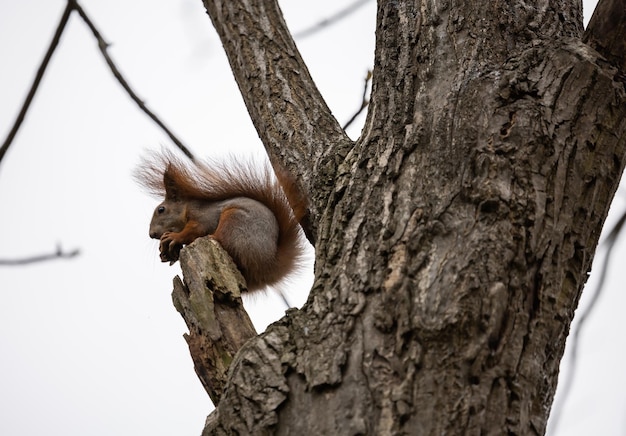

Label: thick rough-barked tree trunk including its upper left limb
[193,0,626,435]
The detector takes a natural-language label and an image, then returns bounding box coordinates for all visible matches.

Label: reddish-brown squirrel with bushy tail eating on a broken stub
[135,153,306,291]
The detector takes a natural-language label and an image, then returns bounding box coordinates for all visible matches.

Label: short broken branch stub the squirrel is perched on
[172,238,257,406]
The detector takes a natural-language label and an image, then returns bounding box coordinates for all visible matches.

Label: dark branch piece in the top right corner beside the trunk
[583,0,626,81]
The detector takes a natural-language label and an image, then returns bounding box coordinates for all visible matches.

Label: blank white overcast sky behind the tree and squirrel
[0,0,626,436]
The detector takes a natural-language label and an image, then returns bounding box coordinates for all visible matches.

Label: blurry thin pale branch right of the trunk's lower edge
[550,212,626,433]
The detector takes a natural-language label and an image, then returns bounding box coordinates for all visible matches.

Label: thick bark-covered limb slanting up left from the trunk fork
[204,0,352,234]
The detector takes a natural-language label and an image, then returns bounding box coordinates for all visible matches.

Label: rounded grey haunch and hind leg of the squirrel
[212,205,279,291]
